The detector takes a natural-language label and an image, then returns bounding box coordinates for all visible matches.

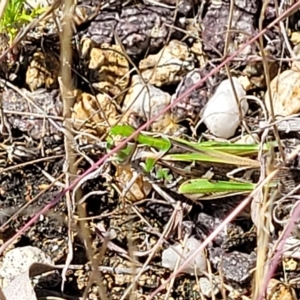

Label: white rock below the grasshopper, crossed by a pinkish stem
[162,237,207,274]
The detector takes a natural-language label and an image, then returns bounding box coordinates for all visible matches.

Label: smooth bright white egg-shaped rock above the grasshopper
[202,77,248,139]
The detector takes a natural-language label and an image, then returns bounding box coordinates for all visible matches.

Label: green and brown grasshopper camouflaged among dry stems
[110,125,276,200]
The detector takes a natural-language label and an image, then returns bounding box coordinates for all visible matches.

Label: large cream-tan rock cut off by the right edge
[265,70,300,116]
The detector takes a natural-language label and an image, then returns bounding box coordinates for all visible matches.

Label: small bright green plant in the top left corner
[0,0,46,44]
